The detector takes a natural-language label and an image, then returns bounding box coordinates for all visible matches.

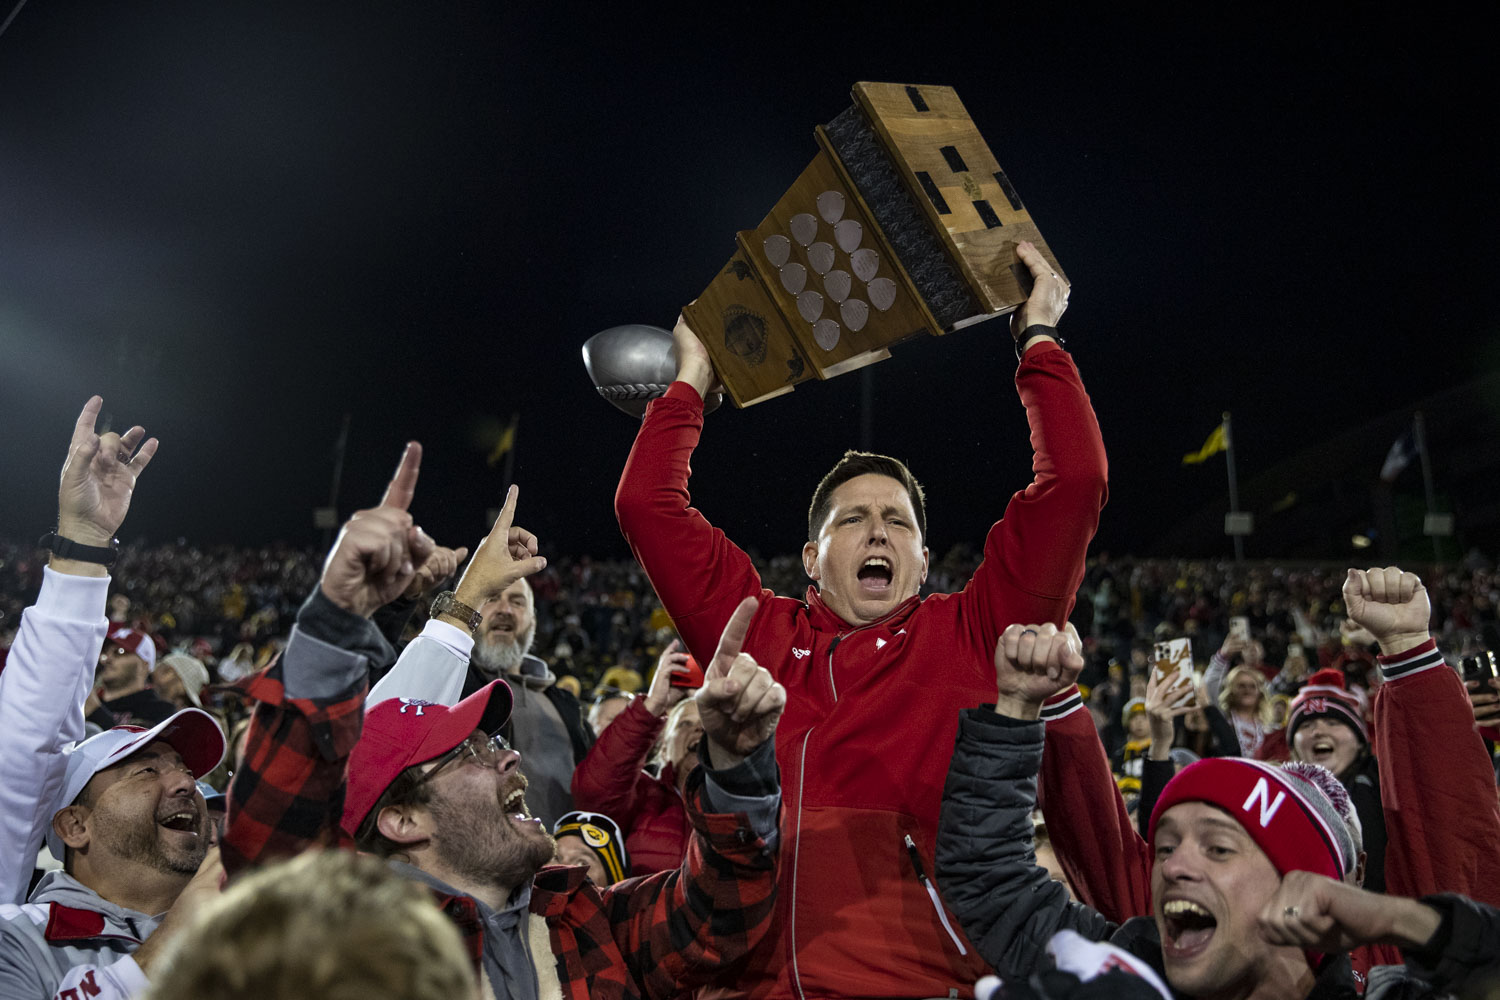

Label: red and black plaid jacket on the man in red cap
[221,664,776,1000]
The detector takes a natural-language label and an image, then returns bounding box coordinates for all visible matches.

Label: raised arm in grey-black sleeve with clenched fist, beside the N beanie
[938,625,1115,979]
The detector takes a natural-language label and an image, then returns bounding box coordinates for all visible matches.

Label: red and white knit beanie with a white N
[1146,757,1358,879]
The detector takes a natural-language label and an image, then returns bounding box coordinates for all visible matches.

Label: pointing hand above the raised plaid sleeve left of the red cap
[320,441,437,618]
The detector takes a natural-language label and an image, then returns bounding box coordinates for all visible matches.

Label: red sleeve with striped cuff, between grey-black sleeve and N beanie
[1037,688,1151,924]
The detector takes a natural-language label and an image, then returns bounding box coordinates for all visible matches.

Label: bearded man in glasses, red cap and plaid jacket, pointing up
[344,593,786,1000]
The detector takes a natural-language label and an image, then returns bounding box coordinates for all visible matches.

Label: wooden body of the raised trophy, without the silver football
[683,84,1062,406]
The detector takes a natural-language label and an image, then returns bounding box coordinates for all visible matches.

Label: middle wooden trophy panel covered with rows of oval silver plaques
[740,150,941,379]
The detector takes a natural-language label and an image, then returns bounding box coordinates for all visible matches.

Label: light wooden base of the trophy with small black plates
[854,82,1064,325]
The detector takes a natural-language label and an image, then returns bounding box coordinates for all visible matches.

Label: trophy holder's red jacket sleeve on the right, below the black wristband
[963,342,1109,649]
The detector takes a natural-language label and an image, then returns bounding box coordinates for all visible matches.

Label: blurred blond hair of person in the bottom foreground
[146,850,479,1000]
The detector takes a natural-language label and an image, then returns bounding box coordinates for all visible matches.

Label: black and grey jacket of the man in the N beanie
[938,709,1500,1000]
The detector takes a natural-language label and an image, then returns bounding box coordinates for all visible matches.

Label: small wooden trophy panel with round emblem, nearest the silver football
[683,250,813,406]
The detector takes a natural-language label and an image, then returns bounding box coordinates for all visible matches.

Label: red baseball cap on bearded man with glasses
[342,681,512,837]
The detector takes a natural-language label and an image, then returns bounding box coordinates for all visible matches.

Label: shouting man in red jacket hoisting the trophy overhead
[615,243,1107,1000]
